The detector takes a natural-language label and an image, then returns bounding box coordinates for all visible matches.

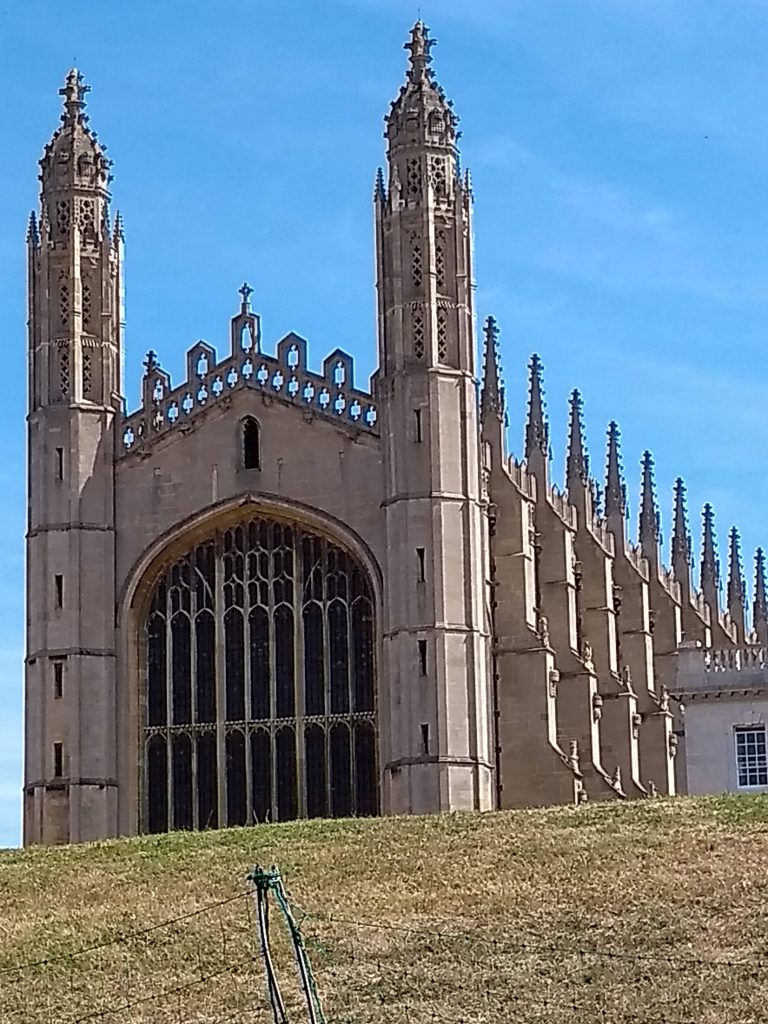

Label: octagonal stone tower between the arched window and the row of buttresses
[375,23,493,813]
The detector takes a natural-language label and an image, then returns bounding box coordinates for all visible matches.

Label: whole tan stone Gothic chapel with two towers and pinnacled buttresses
[25,23,768,843]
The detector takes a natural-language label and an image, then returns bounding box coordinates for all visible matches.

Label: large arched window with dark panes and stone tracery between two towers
[143,517,379,831]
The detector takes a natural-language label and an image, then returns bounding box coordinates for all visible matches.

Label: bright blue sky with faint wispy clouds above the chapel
[0,0,768,846]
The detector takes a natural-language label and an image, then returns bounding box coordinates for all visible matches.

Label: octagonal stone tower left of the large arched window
[25,70,122,843]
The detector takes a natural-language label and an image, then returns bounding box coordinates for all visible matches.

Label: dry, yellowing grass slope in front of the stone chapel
[0,797,768,1024]
